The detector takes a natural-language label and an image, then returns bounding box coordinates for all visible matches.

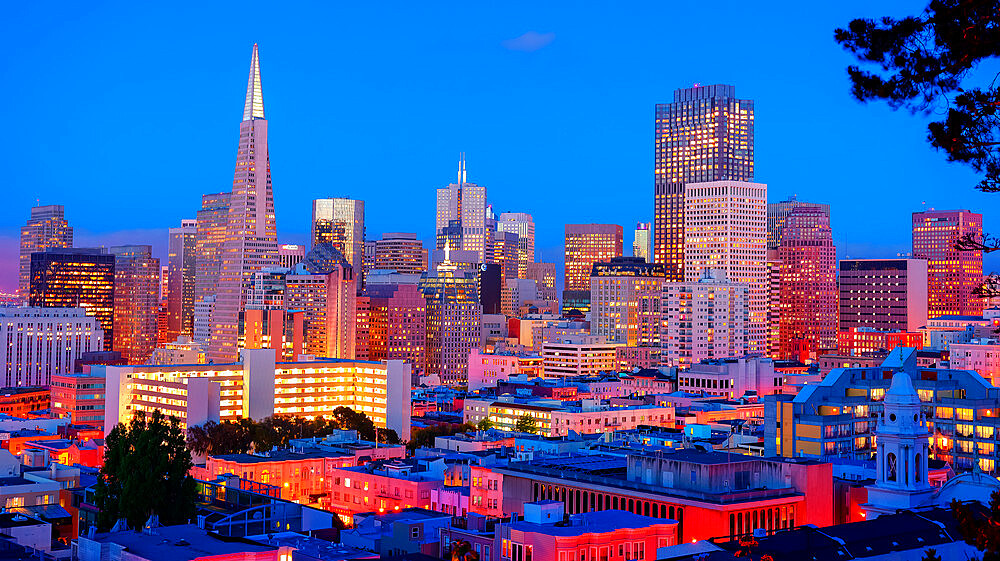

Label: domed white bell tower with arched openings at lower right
[861,372,934,520]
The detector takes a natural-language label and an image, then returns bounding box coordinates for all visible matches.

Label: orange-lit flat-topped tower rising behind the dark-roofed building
[563,224,623,311]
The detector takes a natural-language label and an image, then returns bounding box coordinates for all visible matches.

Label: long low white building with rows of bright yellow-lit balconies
[103,349,410,440]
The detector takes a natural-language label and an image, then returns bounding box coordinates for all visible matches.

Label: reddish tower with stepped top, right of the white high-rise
[778,206,838,361]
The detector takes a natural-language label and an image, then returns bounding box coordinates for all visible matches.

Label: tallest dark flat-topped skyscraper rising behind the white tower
[653,84,754,281]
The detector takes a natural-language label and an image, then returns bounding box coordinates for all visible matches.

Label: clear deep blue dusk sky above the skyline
[0,1,1000,289]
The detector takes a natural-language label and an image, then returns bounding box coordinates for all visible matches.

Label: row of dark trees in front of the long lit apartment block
[187,407,400,456]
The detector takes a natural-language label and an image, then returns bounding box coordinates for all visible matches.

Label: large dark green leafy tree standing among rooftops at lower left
[95,410,197,529]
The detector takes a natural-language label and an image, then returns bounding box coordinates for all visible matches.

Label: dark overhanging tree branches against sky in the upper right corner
[834,0,1000,191]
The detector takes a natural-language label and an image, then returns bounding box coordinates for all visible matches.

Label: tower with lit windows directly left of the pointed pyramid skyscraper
[194,193,230,306]
